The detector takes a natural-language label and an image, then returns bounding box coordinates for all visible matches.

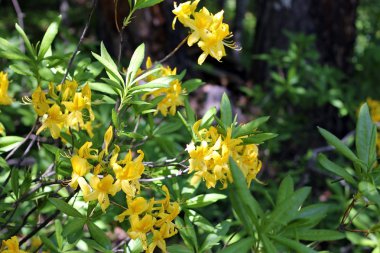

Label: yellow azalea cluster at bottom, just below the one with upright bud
[117,186,180,253]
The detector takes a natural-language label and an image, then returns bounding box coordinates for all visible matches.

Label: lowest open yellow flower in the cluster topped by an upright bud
[84,175,119,212]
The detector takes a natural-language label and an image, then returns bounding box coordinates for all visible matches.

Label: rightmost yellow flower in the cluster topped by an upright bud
[113,150,144,198]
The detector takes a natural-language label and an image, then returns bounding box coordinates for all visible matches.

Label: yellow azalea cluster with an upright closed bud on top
[70,126,144,212]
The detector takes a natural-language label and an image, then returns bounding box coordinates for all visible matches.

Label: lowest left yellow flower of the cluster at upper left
[36,104,66,139]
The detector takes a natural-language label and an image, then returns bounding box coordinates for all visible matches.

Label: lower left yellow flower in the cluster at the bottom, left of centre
[127,214,156,250]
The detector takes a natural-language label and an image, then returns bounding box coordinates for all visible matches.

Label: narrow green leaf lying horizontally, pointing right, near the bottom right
[281,228,345,241]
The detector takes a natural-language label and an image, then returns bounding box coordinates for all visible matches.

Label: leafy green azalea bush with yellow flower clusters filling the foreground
[0,0,379,253]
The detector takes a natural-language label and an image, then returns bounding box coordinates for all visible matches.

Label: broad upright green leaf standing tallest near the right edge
[355,104,376,169]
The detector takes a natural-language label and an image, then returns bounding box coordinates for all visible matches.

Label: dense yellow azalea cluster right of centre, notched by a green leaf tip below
[186,120,261,189]
